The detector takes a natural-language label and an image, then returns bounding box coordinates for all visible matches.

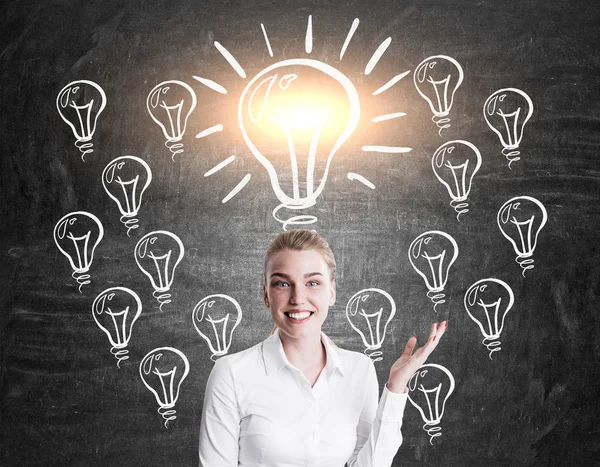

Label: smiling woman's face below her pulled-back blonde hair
[264,250,335,339]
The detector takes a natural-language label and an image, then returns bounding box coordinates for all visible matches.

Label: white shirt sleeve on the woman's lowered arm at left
[199,359,240,467]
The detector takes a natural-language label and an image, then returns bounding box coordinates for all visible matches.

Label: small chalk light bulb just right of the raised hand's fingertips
[464,277,515,360]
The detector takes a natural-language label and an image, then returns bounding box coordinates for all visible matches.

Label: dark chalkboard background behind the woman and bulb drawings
[0,0,600,466]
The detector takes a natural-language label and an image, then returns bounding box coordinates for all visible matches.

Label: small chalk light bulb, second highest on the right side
[483,88,533,168]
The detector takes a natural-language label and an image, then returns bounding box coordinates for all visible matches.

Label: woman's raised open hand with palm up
[387,321,448,393]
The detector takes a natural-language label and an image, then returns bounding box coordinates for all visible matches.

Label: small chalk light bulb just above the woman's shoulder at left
[192,294,242,361]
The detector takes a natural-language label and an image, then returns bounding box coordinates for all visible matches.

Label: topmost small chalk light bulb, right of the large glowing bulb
[413,55,464,136]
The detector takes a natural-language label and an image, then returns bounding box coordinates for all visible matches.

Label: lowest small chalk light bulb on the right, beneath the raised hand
[408,363,455,445]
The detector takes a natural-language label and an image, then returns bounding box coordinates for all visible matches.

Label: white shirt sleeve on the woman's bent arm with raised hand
[346,362,408,467]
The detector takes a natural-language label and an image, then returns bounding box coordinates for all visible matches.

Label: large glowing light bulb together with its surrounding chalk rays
[194,15,411,230]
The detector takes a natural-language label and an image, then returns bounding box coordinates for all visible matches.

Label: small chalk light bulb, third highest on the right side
[431,140,481,220]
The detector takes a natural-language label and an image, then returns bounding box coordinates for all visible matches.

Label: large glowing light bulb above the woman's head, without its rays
[238,59,360,229]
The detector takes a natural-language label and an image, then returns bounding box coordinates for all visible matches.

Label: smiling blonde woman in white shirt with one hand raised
[199,230,447,467]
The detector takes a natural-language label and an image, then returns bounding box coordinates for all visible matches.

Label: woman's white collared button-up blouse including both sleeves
[199,330,407,467]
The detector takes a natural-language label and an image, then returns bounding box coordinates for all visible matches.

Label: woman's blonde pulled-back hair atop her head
[264,229,335,282]
